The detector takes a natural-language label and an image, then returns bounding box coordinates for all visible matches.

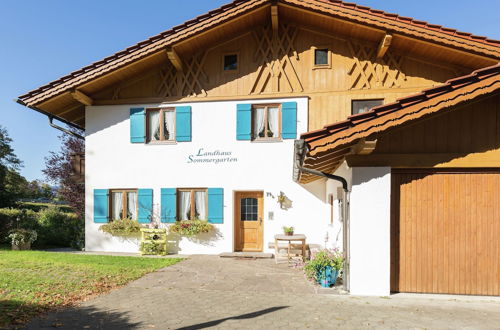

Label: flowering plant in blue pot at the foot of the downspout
[304,248,344,288]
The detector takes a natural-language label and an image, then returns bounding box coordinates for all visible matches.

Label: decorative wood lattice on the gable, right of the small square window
[347,41,406,89]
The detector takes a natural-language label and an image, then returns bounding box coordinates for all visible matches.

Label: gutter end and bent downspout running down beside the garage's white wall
[294,140,351,292]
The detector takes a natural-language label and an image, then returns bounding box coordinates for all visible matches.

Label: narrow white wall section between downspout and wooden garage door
[350,167,391,296]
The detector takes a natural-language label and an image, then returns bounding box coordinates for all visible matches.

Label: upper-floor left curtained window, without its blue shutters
[146,109,175,142]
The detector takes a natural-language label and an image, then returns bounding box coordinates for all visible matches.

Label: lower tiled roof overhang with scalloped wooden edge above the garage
[294,64,500,183]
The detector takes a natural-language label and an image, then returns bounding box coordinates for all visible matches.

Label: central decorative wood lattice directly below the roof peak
[249,24,304,94]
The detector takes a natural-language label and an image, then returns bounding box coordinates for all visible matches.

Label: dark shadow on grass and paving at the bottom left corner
[25,307,143,330]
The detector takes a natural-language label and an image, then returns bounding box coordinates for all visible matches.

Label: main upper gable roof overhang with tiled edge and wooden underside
[18,0,500,128]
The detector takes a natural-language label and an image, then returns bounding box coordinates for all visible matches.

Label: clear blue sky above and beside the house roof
[0,0,500,180]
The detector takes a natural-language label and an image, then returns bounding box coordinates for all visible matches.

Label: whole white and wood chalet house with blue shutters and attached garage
[18,0,500,295]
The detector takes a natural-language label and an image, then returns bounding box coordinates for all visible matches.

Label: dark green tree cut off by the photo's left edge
[0,126,26,207]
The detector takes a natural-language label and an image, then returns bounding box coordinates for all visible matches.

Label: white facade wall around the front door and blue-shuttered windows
[85,98,334,254]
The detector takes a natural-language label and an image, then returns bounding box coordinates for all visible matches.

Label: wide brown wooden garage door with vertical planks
[391,170,500,295]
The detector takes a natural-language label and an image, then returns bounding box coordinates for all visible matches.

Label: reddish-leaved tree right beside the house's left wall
[42,128,85,220]
